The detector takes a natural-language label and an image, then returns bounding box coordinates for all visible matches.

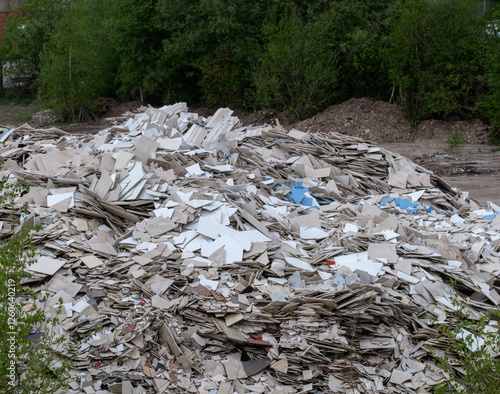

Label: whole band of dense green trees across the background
[0,0,500,135]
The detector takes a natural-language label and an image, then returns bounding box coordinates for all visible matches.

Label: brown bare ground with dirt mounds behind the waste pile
[0,98,500,205]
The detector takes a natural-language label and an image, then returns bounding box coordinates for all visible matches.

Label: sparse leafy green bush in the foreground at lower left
[0,163,70,394]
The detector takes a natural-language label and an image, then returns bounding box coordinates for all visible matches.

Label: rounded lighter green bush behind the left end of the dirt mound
[255,7,339,119]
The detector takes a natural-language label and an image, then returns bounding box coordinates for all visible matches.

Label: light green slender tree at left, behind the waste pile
[37,0,115,120]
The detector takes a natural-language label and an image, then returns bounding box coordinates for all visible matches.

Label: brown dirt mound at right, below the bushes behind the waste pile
[293,98,489,144]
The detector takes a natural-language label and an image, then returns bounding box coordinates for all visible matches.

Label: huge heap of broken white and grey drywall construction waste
[0,103,500,394]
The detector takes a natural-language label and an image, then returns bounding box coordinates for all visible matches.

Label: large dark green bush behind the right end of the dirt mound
[385,0,491,121]
